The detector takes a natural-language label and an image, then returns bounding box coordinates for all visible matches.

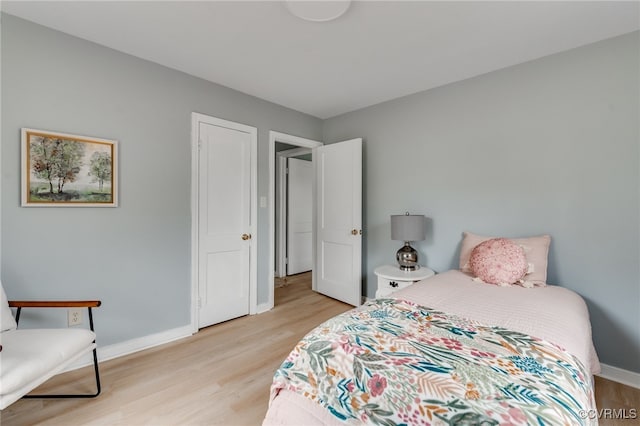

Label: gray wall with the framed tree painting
[1,14,322,345]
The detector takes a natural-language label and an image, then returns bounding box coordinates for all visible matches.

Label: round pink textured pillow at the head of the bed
[469,238,529,285]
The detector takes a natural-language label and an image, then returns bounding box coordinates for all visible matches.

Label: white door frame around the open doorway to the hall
[268,130,324,311]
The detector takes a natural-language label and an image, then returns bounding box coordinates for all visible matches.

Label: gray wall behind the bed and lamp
[324,32,640,372]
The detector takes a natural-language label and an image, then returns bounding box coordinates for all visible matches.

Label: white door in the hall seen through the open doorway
[287,158,313,275]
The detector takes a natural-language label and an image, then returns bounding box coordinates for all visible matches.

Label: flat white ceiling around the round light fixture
[1,1,640,118]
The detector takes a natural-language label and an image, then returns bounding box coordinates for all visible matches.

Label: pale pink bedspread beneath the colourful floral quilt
[263,270,600,426]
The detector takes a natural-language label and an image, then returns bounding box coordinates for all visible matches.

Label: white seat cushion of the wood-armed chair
[0,328,96,396]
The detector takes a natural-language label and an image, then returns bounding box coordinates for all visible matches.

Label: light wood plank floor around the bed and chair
[0,274,640,426]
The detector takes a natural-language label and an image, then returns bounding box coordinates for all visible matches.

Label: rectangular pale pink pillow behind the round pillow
[460,232,551,287]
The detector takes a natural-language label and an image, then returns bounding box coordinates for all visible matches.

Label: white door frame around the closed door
[191,112,258,333]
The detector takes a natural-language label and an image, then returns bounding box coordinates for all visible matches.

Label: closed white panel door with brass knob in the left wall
[197,115,257,328]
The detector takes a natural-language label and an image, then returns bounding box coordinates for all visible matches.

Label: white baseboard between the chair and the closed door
[65,325,193,371]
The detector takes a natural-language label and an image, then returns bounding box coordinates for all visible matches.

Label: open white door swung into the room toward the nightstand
[313,139,362,306]
